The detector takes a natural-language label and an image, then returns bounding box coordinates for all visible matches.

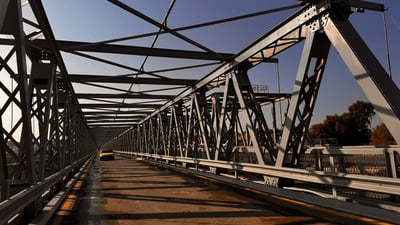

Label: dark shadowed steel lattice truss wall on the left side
[0,1,95,223]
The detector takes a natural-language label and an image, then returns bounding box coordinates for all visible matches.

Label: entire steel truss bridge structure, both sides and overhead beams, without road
[0,0,400,224]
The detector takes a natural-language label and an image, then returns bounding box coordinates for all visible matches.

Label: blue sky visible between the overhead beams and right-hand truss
[39,0,400,126]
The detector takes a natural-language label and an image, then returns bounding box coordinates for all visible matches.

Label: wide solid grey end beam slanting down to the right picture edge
[324,13,400,143]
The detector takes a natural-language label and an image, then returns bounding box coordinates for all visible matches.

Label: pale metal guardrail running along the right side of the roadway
[116,148,400,198]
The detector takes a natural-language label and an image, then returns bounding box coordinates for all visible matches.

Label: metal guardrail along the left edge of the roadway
[0,154,92,224]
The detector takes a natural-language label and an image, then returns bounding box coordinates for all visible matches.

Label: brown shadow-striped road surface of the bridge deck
[52,158,390,225]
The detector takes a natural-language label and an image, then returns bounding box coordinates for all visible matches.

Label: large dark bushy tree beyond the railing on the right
[309,101,375,145]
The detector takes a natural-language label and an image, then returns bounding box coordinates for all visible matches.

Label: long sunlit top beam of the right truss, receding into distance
[142,1,330,122]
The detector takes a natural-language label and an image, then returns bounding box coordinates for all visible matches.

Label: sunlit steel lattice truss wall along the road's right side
[106,1,399,185]
